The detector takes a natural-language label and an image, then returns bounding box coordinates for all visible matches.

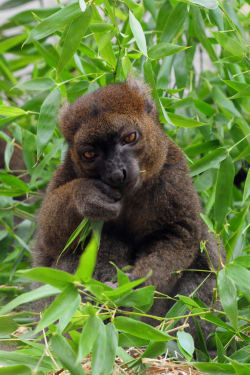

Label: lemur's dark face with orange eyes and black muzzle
[73,116,143,194]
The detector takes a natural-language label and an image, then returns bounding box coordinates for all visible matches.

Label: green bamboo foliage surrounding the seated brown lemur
[0,0,250,375]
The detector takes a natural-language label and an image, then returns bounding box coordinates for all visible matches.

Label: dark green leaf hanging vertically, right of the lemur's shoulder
[214,156,234,232]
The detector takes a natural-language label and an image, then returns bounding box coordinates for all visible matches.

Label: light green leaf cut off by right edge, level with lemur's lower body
[226,264,250,301]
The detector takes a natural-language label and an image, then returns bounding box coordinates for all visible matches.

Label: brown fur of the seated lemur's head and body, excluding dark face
[34,80,218,328]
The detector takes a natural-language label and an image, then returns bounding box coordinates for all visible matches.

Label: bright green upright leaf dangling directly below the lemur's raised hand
[75,222,103,283]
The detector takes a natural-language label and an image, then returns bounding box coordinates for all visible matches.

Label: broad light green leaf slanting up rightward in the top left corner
[26,3,81,43]
